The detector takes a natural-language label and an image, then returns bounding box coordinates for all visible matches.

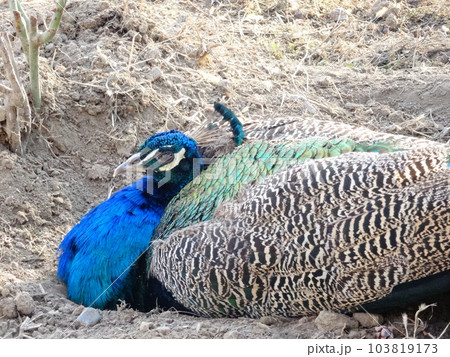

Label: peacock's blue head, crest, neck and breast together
[57,110,244,309]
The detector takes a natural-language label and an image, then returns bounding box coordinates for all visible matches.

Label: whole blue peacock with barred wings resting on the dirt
[58,101,449,317]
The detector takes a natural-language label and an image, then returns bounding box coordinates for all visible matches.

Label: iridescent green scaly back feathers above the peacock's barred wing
[153,138,393,239]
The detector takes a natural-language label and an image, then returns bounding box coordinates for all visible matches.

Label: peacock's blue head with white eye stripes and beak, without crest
[114,130,203,192]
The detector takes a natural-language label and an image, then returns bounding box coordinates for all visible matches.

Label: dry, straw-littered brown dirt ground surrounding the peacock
[0,0,450,338]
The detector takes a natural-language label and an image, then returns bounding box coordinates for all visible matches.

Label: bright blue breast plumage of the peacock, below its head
[58,178,167,308]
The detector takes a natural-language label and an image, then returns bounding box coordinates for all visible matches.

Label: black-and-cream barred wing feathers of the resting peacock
[148,147,450,318]
